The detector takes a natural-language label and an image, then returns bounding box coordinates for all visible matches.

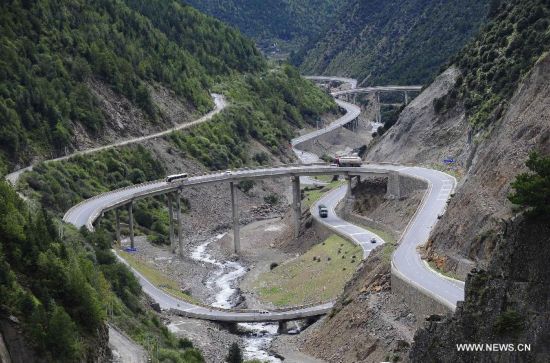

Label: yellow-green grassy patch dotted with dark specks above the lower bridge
[254,235,363,306]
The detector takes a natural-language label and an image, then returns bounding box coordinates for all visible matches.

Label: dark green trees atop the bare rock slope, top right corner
[434,0,550,129]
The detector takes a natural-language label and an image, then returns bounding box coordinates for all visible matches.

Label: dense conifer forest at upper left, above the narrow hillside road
[0,0,265,173]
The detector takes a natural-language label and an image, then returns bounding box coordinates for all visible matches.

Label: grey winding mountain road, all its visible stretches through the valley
[8,79,464,322]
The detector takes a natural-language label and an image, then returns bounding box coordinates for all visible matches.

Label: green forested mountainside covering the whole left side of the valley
[0,0,337,362]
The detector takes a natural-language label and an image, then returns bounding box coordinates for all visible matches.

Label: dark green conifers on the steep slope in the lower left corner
[0,181,109,361]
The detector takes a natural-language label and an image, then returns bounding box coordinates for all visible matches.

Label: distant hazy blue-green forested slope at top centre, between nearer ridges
[184,0,343,54]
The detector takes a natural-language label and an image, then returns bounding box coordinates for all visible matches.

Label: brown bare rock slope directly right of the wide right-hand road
[428,55,550,274]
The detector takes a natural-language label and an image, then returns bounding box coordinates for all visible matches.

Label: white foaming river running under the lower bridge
[191,233,281,363]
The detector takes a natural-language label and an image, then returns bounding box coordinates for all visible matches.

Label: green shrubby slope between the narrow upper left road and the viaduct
[19,66,337,243]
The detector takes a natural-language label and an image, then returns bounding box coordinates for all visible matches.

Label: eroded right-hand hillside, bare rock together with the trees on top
[368,0,550,276]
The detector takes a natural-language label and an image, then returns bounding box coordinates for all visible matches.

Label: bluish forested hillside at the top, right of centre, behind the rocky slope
[298,0,489,85]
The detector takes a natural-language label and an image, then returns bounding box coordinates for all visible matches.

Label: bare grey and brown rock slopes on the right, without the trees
[368,55,550,276]
